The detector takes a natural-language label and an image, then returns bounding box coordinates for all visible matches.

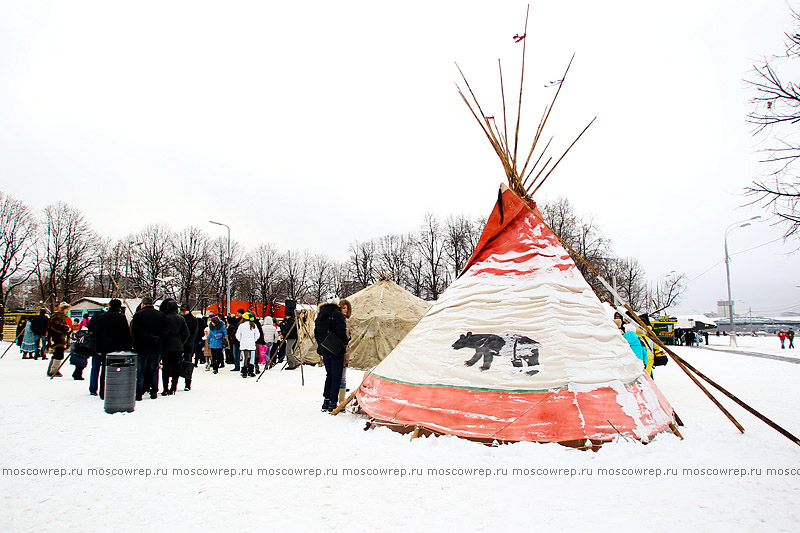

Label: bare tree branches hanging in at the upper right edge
[745,10,800,238]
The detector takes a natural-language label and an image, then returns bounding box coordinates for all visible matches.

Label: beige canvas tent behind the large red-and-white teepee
[347,280,431,370]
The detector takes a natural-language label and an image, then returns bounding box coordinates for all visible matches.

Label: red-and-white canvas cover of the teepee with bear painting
[357,186,673,442]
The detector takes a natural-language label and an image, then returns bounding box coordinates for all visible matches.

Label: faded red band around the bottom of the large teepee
[357,375,672,442]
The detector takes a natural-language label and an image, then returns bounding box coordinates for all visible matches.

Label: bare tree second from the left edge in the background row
[36,202,95,304]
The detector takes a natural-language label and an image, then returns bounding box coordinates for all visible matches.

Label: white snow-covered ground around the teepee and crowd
[0,337,800,531]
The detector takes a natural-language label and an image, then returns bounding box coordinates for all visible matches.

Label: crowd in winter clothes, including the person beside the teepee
[11,294,352,412]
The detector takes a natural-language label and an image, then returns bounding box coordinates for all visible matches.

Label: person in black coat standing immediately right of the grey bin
[131,296,167,400]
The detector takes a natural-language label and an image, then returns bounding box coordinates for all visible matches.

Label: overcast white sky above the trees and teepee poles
[0,0,800,313]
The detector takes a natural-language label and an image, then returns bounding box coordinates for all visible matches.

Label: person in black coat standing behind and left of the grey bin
[87,298,131,398]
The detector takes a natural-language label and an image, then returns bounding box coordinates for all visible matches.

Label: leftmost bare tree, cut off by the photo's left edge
[0,191,36,306]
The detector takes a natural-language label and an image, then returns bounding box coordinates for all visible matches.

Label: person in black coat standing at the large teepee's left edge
[314,293,348,412]
